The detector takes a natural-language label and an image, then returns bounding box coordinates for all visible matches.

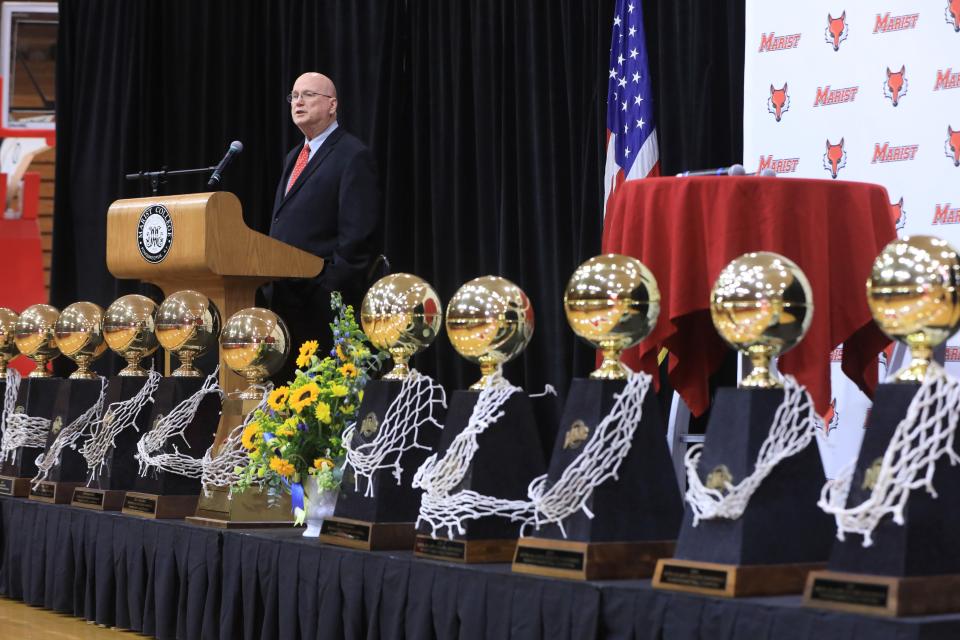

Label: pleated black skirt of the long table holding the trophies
[0,498,960,640]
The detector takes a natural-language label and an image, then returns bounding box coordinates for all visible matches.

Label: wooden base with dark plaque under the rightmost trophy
[803,571,960,616]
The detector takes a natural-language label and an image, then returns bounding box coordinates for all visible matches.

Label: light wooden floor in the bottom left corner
[0,597,135,640]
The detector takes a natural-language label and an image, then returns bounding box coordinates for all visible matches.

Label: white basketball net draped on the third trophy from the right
[524,373,653,538]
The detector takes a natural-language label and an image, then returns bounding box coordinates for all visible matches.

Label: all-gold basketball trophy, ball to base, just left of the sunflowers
[187,307,293,529]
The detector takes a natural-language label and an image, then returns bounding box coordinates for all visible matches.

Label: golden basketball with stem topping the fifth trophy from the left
[157,289,220,378]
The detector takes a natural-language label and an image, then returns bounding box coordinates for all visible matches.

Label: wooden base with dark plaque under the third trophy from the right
[513,538,675,580]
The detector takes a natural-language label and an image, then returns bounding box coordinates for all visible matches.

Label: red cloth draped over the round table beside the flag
[603,177,896,415]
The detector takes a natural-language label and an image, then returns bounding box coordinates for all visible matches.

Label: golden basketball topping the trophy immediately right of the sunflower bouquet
[360,273,443,380]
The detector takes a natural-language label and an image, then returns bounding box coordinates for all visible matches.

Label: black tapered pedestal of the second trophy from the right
[675,388,835,568]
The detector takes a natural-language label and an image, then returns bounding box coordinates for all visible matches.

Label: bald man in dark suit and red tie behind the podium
[264,72,382,383]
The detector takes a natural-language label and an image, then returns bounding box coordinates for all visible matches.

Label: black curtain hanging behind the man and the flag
[51,0,743,391]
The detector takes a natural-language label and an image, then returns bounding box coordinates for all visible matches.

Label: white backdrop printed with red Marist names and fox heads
[743,0,960,477]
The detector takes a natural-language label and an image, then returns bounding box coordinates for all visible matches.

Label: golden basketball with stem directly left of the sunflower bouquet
[220,307,290,400]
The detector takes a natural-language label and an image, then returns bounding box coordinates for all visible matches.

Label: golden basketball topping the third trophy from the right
[563,253,660,380]
